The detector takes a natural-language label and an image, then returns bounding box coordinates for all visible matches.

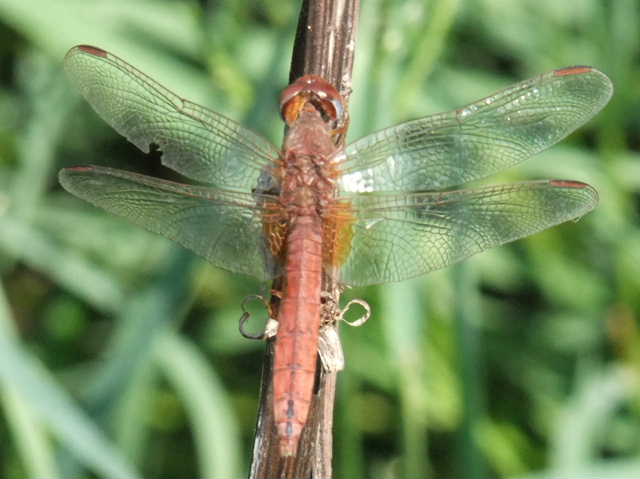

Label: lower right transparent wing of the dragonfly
[336,180,598,286]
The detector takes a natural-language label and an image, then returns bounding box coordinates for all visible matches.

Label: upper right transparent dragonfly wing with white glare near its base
[339,67,613,194]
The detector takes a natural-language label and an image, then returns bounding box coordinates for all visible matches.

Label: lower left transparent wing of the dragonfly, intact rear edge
[59,166,279,280]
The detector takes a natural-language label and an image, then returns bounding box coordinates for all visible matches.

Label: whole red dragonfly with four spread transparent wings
[59,45,613,457]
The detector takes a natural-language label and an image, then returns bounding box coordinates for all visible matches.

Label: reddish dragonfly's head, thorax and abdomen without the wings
[273,75,344,456]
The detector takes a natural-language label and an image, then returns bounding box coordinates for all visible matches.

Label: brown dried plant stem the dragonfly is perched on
[250,0,360,478]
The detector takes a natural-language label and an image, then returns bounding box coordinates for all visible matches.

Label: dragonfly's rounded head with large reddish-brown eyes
[280,75,348,135]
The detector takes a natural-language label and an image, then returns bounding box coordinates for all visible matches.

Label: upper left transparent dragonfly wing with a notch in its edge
[65,45,278,191]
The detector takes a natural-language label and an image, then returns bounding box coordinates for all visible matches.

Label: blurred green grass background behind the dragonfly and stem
[0,0,640,478]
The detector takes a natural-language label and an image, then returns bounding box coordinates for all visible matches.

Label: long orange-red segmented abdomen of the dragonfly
[273,216,322,456]
